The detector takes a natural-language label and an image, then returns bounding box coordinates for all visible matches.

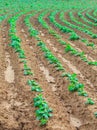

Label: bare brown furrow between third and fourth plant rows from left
[44,11,97,60]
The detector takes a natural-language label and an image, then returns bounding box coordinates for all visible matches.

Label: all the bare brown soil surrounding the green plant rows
[0,9,97,130]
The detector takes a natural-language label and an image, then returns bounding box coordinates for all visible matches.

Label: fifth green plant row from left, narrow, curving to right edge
[59,12,97,38]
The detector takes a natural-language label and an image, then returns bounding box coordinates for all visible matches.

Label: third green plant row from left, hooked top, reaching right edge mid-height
[38,12,97,66]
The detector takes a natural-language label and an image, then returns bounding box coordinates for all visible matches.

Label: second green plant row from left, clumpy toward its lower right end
[24,12,94,105]
